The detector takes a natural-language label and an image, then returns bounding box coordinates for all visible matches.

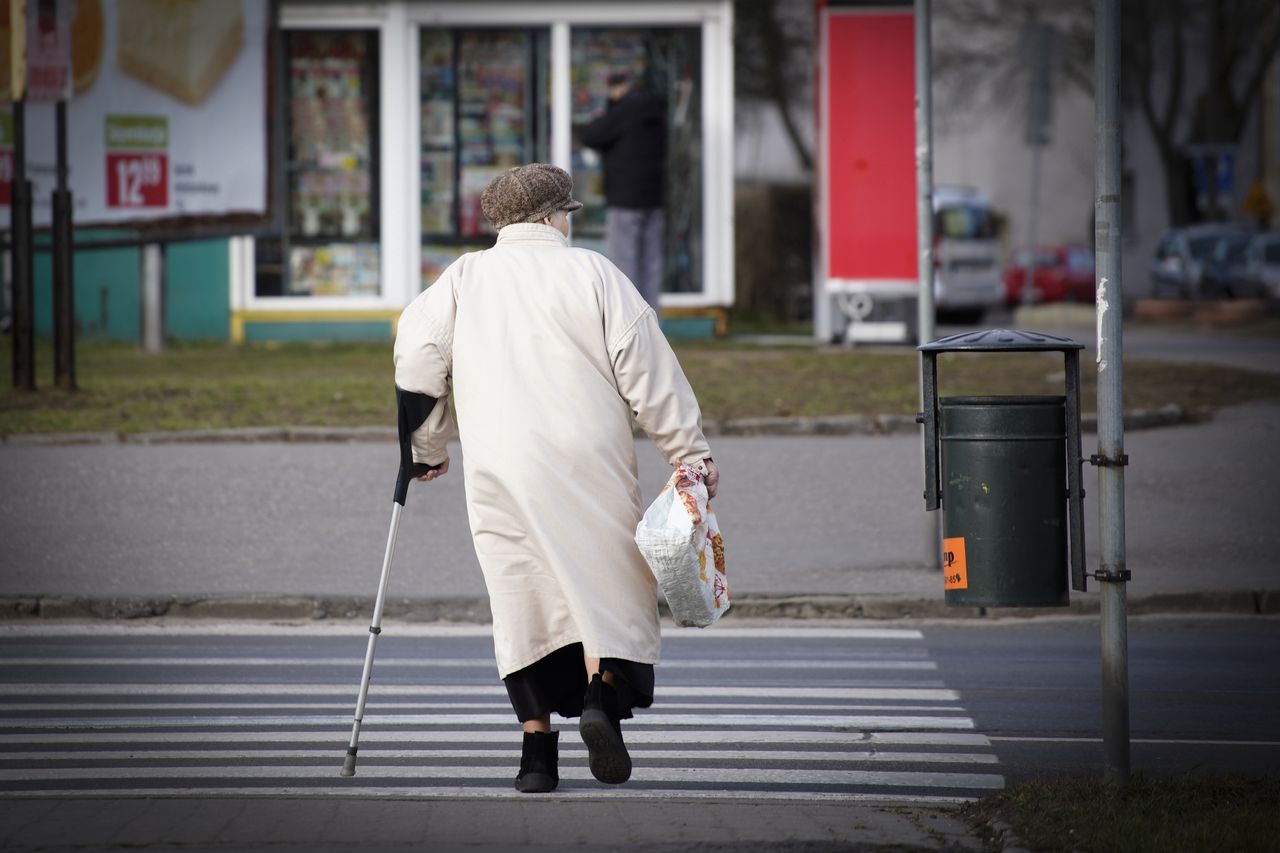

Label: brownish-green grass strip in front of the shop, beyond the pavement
[0,338,1280,435]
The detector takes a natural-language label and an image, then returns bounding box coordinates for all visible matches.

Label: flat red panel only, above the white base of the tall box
[823,9,918,283]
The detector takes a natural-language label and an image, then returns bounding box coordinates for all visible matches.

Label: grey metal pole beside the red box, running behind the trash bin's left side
[915,0,942,570]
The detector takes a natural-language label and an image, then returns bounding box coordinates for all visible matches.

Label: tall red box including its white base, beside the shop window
[814,0,919,342]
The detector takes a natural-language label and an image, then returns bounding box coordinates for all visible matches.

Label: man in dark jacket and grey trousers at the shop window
[581,73,667,308]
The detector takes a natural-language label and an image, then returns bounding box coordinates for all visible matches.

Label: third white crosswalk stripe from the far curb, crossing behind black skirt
[0,678,960,702]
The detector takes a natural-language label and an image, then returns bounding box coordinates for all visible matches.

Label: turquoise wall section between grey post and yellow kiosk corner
[164,240,232,341]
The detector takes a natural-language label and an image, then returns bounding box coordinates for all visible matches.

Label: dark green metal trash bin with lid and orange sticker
[918,329,1085,607]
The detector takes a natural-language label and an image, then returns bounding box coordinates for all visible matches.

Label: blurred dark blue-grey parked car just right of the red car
[1151,223,1253,298]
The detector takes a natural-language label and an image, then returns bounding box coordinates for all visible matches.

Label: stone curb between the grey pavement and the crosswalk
[0,589,1280,624]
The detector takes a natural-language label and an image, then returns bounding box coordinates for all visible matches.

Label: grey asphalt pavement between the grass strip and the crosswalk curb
[0,394,1280,598]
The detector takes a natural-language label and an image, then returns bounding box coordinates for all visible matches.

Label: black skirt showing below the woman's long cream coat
[502,643,653,722]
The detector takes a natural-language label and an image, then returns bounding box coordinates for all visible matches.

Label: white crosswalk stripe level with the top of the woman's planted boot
[0,725,991,749]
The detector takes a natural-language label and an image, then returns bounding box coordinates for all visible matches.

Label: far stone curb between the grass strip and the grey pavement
[0,403,1194,447]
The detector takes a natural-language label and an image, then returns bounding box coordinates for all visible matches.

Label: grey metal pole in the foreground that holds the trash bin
[1091,0,1129,784]
